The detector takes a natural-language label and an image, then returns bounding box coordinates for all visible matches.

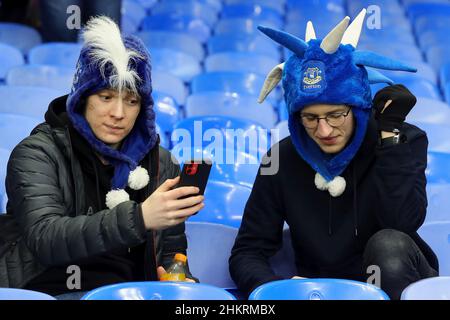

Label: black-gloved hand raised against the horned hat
[373,84,417,132]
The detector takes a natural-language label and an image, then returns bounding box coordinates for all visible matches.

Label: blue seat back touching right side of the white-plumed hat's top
[136,31,205,61]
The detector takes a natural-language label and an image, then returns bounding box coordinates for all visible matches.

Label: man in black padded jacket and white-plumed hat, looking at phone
[0,17,203,295]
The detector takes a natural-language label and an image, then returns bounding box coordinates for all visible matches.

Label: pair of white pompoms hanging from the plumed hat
[106,166,150,209]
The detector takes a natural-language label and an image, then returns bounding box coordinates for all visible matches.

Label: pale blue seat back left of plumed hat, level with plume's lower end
[6,64,74,93]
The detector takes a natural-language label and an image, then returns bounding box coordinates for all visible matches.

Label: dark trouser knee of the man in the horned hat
[363,229,438,300]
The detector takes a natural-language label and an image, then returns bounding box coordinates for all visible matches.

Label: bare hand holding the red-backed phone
[141,177,205,230]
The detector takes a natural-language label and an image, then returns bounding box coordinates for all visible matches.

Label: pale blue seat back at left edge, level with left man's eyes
[0,86,68,119]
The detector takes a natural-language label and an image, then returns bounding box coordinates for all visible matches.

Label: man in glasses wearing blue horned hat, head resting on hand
[230,10,438,299]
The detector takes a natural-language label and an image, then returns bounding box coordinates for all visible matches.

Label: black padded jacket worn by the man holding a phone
[0,96,190,294]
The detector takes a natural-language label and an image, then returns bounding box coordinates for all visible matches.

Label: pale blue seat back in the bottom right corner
[400,277,450,300]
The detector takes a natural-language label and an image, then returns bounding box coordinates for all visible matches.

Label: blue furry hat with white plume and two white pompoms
[66,16,157,209]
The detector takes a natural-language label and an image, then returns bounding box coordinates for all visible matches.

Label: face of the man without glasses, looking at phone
[84,89,141,148]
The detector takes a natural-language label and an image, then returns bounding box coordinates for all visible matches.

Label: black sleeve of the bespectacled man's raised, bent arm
[374,128,428,233]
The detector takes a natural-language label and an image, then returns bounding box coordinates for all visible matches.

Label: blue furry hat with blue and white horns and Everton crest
[258,9,416,196]
